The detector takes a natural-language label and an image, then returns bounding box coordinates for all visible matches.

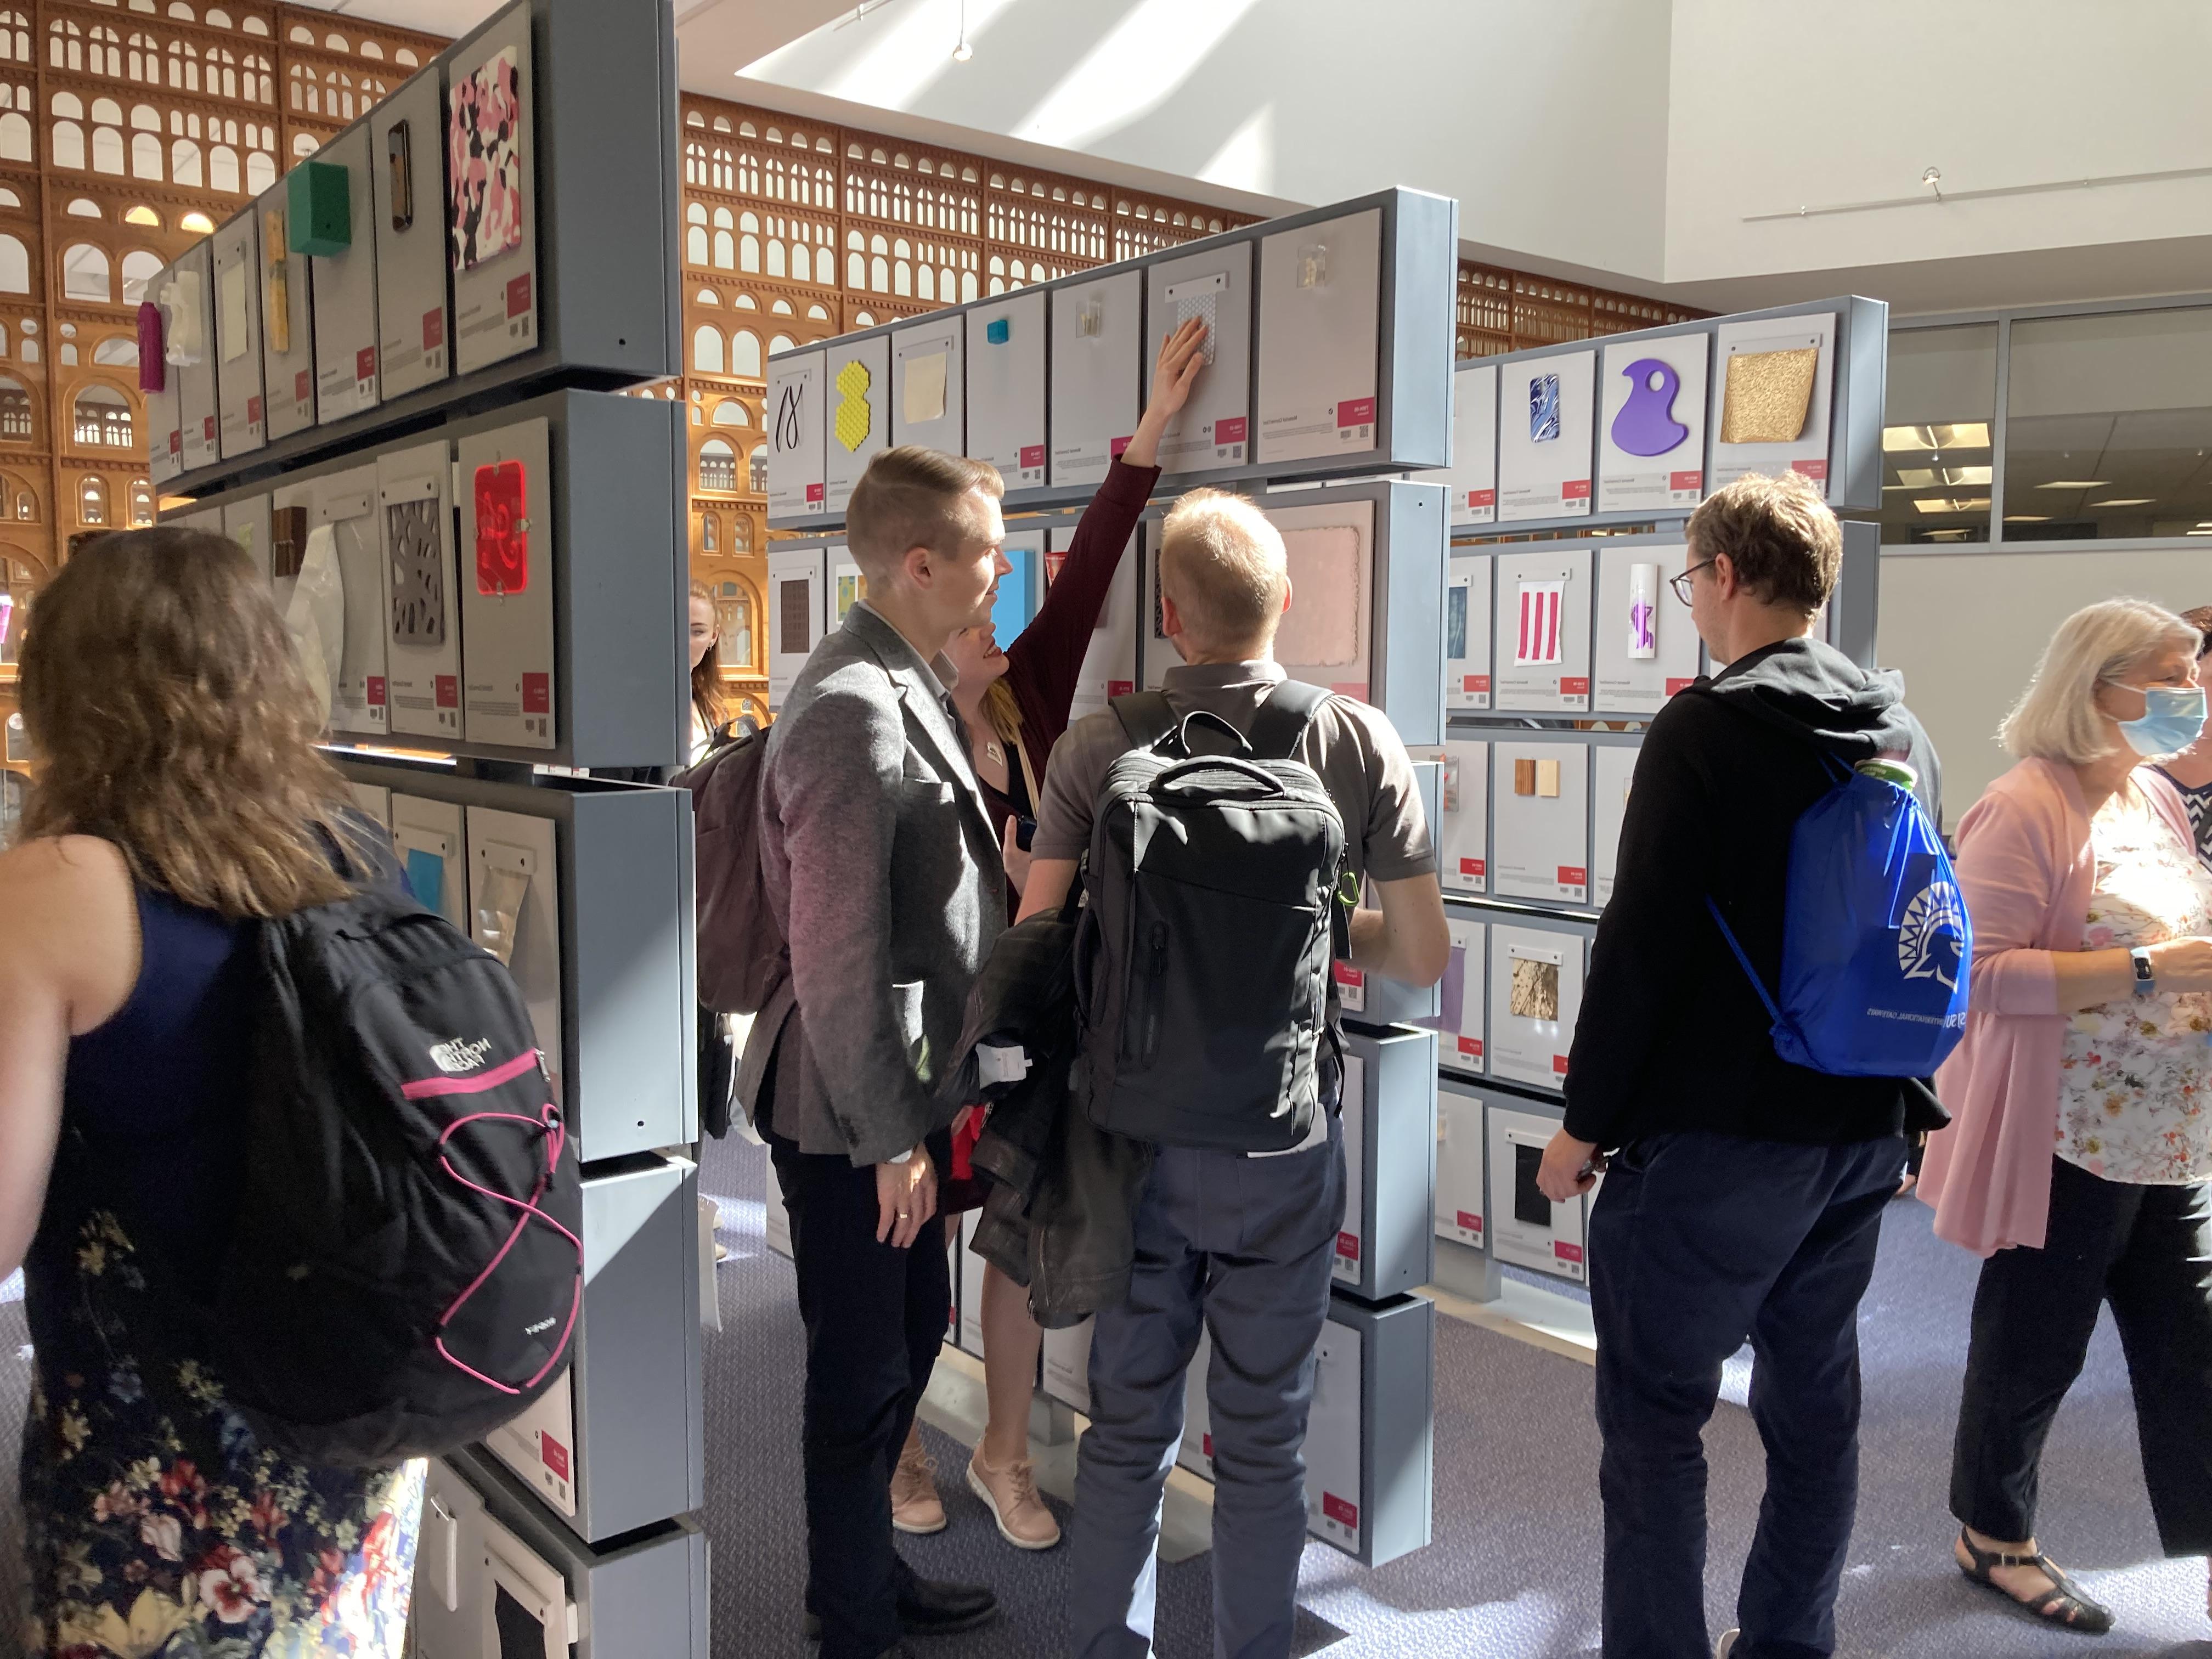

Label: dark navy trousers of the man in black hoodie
[1590,1132,1905,1659]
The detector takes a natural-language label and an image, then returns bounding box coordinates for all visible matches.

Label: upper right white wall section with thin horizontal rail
[1666,0,2212,281]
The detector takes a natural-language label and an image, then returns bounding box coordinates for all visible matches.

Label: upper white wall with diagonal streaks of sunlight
[737,0,1668,279]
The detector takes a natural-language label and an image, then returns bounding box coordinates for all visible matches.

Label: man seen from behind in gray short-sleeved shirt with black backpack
[1022,491,1451,1659]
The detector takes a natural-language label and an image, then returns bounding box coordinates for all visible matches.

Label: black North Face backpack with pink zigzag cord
[204,887,584,1466]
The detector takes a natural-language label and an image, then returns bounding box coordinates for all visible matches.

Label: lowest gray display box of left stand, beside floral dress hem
[422,1449,710,1659]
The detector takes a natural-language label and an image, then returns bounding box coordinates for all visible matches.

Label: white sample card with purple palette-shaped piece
[1597,334,1712,513]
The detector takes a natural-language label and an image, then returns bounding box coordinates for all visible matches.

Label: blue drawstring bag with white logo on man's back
[1706,757,1973,1077]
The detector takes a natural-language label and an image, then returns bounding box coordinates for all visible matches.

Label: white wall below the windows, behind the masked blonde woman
[1878,549,2212,830]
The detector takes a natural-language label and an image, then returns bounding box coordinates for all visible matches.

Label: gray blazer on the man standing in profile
[737,602,1007,1164]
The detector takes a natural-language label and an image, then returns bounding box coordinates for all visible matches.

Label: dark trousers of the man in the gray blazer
[765,1128,951,1659]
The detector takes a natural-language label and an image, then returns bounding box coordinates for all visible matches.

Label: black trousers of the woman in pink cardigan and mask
[1951,1159,2212,1555]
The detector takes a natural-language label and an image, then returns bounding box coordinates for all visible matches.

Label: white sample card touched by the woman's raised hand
[1144,241,1252,478]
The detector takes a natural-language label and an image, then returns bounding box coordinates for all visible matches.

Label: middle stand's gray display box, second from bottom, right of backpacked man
[1331,1026,1436,1303]
